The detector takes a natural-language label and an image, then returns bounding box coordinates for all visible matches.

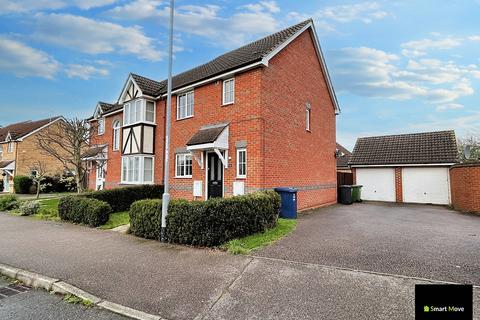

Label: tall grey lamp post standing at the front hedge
[160,0,174,242]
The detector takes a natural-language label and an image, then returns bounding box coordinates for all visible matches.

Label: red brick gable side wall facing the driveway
[261,32,337,209]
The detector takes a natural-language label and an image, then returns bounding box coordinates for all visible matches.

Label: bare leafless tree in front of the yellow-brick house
[37,118,95,193]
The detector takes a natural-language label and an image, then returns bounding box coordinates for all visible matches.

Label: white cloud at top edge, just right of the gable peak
[315,2,388,24]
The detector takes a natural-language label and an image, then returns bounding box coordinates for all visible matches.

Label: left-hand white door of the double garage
[357,168,395,202]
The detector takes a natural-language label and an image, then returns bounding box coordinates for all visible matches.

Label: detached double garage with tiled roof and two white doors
[349,131,458,205]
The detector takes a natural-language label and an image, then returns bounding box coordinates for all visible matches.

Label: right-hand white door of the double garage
[402,167,450,204]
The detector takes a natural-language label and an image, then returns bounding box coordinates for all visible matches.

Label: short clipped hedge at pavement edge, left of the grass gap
[58,196,112,227]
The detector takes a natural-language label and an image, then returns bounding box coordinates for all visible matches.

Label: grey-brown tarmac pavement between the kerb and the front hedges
[0,207,480,319]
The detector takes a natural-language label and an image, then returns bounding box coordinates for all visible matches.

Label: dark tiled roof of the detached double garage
[349,131,458,165]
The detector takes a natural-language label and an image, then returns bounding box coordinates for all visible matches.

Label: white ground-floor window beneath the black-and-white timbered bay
[122,156,154,184]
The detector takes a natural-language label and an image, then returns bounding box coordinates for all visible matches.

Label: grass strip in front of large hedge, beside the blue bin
[221,219,297,254]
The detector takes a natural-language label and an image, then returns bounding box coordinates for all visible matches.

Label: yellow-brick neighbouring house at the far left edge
[0,117,64,192]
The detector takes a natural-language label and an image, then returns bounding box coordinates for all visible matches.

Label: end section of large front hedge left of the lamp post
[129,199,162,239]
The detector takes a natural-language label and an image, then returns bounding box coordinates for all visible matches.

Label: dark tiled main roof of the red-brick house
[131,20,311,96]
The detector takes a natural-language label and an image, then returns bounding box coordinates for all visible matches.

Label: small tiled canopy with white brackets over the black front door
[187,123,228,168]
